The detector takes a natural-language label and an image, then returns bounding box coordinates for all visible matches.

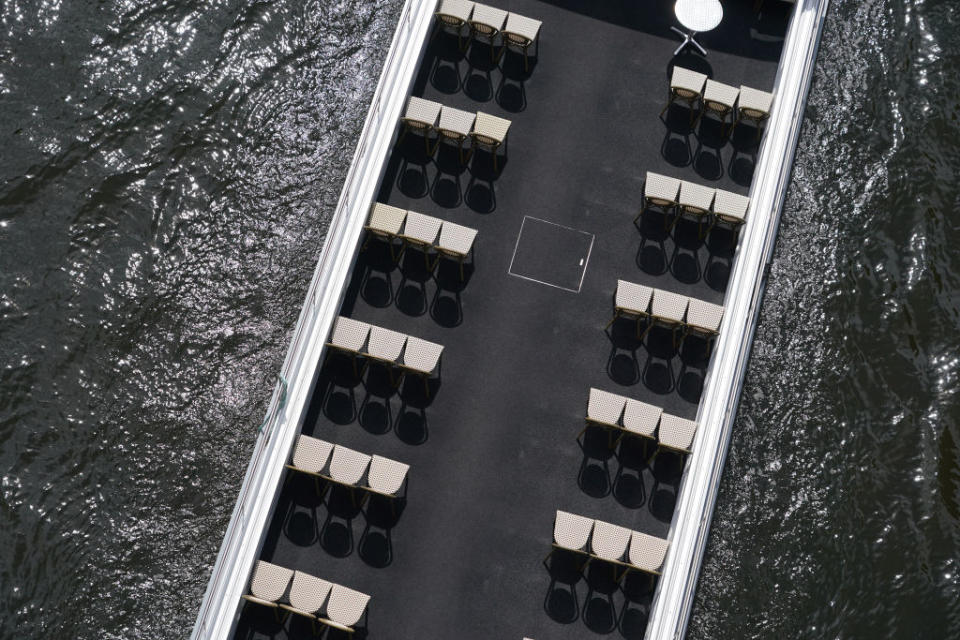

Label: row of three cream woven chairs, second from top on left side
[400,96,511,171]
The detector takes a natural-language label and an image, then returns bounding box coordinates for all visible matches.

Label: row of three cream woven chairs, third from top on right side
[606,280,723,357]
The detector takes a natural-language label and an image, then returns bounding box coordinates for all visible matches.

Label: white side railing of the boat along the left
[191,0,436,640]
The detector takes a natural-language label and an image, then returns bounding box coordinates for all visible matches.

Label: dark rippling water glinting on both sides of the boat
[0,0,960,639]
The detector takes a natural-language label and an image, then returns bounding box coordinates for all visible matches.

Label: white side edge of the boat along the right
[645,0,828,640]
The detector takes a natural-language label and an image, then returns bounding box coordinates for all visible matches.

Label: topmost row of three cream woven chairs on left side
[436,0,543,71]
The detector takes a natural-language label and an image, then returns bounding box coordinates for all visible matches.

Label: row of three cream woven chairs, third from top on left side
[363,202,477,280]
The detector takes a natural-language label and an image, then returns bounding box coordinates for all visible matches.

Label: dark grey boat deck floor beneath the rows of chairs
[235,0,790,640]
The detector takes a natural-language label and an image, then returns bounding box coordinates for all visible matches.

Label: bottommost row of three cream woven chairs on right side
[543,510,669,582]
